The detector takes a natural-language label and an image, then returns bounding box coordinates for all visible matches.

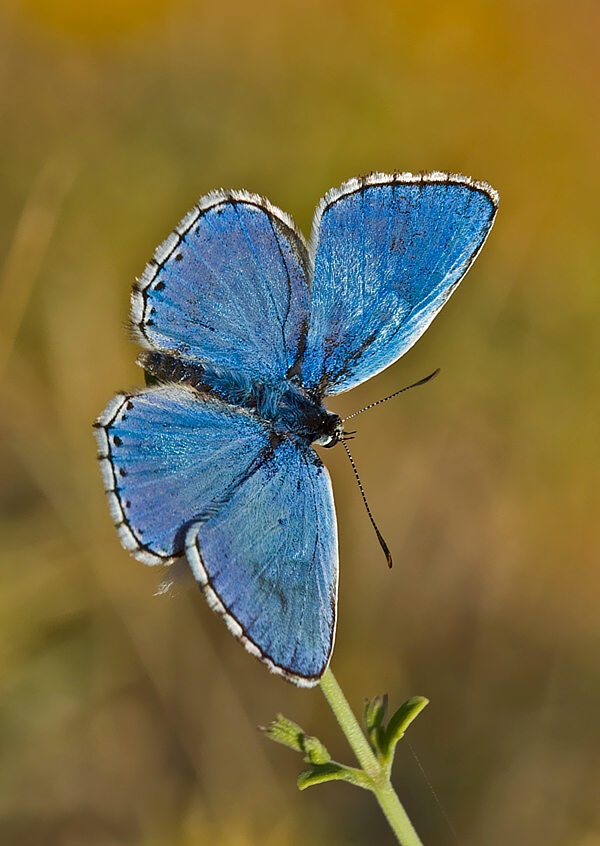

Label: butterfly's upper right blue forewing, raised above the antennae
[302,173,498,395]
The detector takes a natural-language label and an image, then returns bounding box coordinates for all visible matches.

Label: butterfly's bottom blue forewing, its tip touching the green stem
[186,439,338,687]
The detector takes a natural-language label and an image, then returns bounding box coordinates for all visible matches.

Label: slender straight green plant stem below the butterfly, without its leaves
[321,669,423,846]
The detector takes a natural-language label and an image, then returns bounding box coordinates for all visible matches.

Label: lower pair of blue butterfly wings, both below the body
[96,385,338,685]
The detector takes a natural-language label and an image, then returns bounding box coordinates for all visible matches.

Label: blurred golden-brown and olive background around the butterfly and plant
[0,0,600,846]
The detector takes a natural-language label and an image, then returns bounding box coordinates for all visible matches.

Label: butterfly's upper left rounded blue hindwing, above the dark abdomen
[131,191,308,379]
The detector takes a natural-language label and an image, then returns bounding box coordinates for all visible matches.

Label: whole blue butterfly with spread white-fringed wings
[95,172,498,687]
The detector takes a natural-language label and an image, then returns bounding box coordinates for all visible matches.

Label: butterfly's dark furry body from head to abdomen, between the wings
[138,352,343,447]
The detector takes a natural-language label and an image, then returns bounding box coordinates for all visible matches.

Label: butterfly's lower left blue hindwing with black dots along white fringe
[95,386,269,564]
